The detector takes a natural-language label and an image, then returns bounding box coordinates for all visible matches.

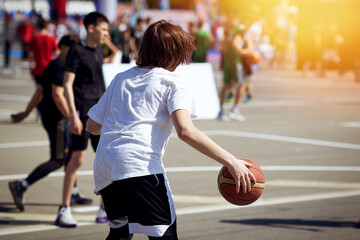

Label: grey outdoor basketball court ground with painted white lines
[0,66,360,240]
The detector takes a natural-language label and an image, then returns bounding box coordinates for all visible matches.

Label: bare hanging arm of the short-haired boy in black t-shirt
[64,71,83,135]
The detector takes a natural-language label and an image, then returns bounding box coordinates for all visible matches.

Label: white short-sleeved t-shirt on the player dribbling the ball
[88,67,195,194]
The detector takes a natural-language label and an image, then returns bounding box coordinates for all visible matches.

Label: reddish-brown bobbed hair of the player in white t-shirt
[136,20,196,68]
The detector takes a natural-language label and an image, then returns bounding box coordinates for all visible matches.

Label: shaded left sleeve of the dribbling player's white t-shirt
[88,81,115,125]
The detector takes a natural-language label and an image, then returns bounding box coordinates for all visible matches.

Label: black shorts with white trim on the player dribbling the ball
[100,174,177,239]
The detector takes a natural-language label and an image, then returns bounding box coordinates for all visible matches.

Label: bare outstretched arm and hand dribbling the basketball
[171,109,256,193]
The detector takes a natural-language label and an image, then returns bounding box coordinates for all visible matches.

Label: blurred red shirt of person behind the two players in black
[29,34,59,77]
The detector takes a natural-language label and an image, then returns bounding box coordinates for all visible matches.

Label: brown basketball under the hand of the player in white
[217,158,265,205]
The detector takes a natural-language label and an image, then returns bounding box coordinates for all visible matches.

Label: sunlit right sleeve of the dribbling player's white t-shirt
[167,79,197,118]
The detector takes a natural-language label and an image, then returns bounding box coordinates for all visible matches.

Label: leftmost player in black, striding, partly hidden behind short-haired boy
[9,35,92,211]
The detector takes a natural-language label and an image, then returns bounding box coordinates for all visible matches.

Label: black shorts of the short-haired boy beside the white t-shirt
[70,117,100,152]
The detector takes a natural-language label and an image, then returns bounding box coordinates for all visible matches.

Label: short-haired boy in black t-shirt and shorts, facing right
[55,12,118,227]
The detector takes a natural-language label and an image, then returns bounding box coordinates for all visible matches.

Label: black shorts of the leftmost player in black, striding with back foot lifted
[43,119,71,160]
